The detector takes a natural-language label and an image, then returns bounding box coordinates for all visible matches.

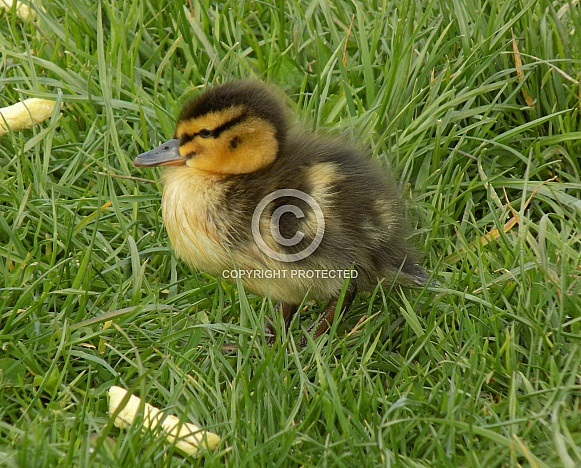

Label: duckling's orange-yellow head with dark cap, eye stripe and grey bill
[133,81,287,176]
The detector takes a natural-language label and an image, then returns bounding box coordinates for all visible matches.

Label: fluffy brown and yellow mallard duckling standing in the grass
[133,81,427,344]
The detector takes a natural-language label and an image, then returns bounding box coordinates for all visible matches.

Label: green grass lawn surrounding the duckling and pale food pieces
[0,0,581,467]
